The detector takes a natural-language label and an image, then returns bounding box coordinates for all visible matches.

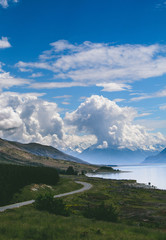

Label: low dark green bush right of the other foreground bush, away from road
[83,203,118,222]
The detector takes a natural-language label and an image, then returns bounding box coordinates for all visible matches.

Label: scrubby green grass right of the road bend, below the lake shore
[62,177,166,229]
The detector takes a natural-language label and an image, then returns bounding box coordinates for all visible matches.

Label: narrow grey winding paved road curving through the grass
[0,181,92,212]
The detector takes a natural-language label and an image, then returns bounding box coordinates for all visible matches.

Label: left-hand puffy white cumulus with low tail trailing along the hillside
[0,92,97,152]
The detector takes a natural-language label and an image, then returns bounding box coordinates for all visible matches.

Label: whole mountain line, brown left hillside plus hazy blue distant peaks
[0,139,166,168]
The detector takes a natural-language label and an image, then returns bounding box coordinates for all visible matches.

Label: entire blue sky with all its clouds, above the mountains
[0,0,166,153]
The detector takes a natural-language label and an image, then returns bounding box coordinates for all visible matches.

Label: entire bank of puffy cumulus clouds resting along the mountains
[0,92,166,152]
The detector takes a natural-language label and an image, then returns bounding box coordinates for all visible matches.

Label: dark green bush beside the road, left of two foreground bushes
[34,193,70,216]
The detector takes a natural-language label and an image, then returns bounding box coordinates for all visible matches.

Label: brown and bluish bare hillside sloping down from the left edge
[0,139,96,171]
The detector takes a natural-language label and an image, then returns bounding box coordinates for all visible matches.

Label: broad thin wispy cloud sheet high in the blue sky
[16,40,166,91]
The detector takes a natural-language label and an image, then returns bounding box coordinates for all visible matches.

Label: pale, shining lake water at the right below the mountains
[86,164,166,190]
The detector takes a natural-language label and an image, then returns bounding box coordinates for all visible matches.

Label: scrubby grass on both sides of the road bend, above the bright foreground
[8,176,166,232]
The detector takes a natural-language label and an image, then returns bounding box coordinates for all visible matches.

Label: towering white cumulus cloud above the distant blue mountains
[66,95,166,150]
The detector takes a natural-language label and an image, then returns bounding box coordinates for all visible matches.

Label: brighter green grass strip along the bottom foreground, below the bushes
[0,206,166,240]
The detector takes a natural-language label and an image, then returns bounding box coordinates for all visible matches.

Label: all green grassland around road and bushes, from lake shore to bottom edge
[0,176,166,240]
